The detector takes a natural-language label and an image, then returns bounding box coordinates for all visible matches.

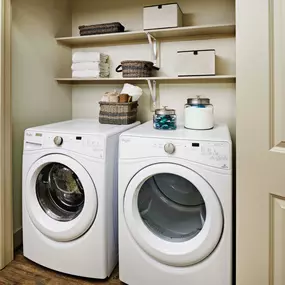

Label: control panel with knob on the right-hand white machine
[120,136,232,169]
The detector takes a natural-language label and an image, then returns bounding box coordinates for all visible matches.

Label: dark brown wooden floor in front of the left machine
[0,251,123,285]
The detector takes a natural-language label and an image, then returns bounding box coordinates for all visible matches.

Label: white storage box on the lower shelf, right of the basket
[177,49,216,77]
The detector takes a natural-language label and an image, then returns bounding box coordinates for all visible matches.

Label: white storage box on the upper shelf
[143,3,182,30]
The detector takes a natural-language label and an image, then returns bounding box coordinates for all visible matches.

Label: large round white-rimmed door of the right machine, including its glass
[124,163,223,266]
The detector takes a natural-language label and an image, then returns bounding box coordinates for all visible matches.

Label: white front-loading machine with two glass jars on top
[119,122,232,285]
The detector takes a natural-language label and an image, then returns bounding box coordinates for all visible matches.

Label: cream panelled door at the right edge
[236,0,285,285]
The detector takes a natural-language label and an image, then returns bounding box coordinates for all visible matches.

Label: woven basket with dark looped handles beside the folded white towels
[116,60,159,78]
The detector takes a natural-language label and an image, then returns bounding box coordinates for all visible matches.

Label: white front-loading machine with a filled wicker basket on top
[23,117,139,279]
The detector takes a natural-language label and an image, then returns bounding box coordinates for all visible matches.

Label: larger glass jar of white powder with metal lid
[184,96,214,130]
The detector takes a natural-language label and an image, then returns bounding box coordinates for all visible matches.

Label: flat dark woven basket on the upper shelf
[78,22,125,36]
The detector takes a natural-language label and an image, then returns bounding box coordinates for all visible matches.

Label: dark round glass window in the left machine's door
[36,163,85,222]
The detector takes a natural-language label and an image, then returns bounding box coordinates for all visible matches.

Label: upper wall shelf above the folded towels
[56,24,235,47]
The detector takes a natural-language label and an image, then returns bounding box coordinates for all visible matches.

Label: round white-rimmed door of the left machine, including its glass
[25,154,98,241]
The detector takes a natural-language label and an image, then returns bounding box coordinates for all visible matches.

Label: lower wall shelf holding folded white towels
[55,75,236,84]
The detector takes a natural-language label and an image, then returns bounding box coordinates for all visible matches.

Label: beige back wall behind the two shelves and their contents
[72,0,235,139]
